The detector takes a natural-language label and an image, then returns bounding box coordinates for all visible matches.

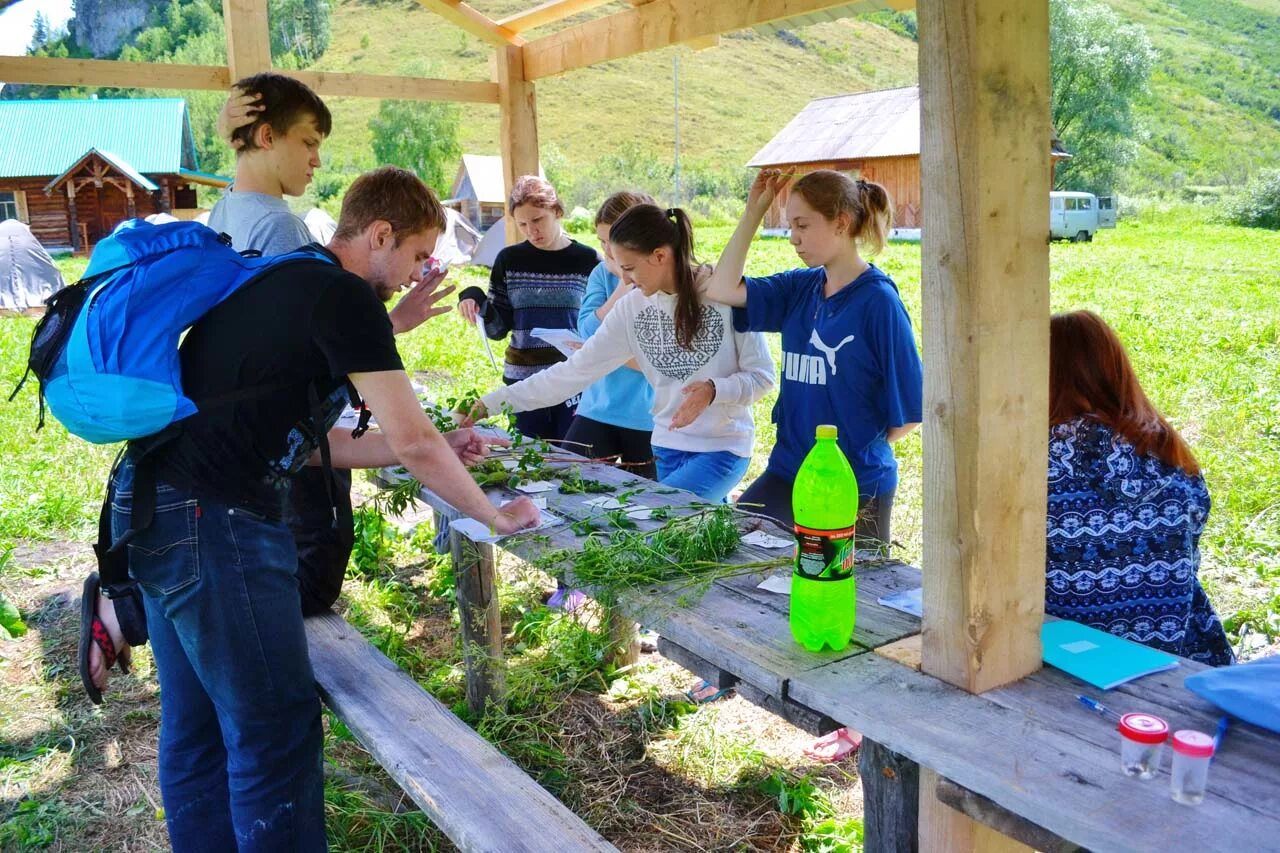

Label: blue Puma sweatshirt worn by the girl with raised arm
[733,265,924,497]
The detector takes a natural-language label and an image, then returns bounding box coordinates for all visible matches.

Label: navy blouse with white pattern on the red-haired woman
[1044,418,1235,666]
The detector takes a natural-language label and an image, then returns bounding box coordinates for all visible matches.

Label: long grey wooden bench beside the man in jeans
[306,613,617,853]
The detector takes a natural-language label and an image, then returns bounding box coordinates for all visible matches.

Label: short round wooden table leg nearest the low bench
[449,530,507,715]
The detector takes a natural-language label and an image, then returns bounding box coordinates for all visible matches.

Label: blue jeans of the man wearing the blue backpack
[111,460,328,853]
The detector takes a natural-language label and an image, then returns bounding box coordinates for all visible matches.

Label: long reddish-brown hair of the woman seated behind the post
[1048,311,1199,475]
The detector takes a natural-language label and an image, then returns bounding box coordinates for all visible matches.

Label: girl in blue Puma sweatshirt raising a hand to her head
[707,169,924,544]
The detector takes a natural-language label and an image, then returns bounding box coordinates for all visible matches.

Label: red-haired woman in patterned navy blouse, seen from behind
[1044,311,1235,666]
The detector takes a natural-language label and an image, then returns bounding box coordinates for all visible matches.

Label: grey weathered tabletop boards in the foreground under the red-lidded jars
[787,654,1280,850]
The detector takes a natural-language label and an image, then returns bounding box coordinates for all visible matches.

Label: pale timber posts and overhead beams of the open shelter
[0,0,1051,850]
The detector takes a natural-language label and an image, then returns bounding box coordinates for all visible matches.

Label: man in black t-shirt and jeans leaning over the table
[103,167,539,853]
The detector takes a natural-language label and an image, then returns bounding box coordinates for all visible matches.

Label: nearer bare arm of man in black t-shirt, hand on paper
[339,370,540,533]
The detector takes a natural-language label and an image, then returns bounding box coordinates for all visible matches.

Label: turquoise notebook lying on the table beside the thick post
[1041,619,1178,690]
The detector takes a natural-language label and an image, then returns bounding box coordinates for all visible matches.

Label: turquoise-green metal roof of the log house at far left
[0,97,200,178]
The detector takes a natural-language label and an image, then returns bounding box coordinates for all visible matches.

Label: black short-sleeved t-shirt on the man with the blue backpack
[155,242,403,517]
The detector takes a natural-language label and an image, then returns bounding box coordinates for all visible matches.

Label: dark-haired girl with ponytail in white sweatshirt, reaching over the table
[471,204,774,502]
